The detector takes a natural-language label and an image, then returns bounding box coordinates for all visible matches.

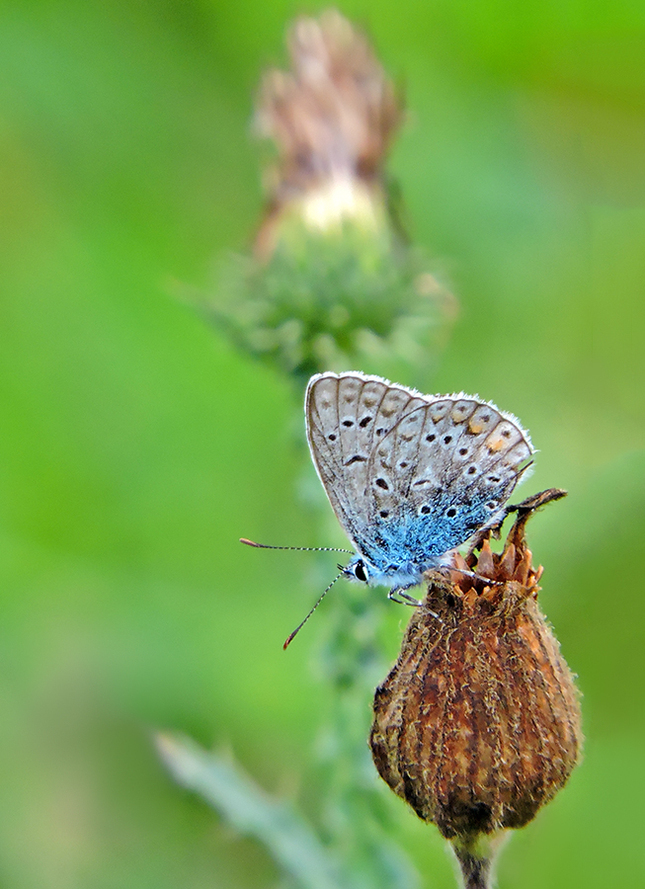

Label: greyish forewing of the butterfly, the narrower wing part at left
[305,372,424,558]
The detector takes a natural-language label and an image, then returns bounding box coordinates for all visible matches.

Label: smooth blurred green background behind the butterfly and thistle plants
[0,0,645,889]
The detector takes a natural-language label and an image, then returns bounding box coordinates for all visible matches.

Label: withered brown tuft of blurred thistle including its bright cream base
[256,10,402,255]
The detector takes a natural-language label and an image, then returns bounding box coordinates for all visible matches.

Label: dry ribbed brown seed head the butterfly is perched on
[370,489,582,886]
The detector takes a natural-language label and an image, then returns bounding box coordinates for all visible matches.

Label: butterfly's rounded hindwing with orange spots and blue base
[367,395,533,567]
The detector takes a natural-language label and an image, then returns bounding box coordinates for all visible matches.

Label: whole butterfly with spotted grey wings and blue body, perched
[305,372,533,590]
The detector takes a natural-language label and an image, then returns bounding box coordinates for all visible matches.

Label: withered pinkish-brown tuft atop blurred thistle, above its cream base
[257,10,402,196]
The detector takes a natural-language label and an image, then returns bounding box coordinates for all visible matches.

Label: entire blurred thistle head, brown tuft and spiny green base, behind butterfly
[210,11,456,381]
